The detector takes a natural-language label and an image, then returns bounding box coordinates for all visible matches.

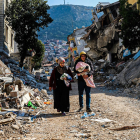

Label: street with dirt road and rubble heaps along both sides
[0,51,140,140]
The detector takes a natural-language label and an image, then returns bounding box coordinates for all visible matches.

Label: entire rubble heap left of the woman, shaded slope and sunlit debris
[0,57,52,139]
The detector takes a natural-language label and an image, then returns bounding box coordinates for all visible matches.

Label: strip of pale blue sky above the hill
[48,0,117,7]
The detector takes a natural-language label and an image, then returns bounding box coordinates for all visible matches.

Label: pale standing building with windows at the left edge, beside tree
[0,0,17,56]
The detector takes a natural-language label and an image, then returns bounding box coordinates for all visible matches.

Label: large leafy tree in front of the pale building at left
[5,0,53,67]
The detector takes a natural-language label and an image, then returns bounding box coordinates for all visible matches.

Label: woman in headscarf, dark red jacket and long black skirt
[49,57,73,115]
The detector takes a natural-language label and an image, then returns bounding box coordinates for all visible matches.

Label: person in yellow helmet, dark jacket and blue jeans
[74,51,94,112]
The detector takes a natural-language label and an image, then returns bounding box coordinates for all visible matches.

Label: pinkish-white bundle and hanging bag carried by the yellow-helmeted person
[76,62,96,88]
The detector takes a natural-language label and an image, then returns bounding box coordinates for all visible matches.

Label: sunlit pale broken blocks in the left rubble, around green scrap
[0,80,49,109]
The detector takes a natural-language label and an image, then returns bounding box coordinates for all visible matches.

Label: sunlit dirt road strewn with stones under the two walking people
[0,82,140,140]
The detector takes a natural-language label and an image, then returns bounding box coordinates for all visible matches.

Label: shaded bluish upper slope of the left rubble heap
[0,58,48,90]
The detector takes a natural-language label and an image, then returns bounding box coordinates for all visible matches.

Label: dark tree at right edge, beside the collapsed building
[120,0,140,50]
